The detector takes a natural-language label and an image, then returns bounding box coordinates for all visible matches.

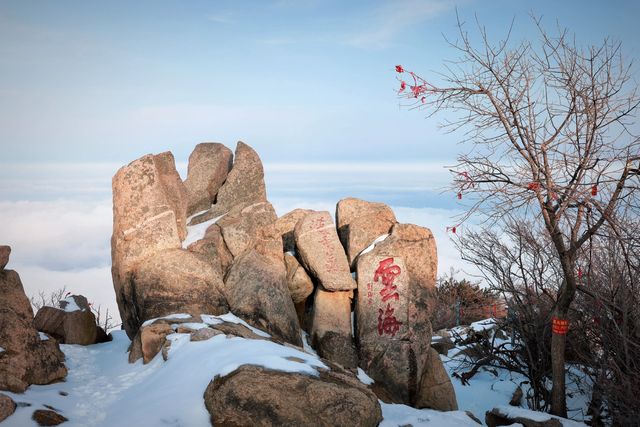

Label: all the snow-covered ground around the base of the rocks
[2,313,582,427]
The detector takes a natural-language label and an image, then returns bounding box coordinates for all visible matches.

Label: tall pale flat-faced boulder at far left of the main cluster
[111,152,188,333]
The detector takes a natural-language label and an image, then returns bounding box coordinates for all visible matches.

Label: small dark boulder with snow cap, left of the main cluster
[33,295,98,345]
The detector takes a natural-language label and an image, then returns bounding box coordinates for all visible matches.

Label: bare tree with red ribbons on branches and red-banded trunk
[396,15,640,416]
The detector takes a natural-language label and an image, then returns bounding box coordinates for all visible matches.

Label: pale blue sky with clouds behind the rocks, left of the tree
[0,0,640,326]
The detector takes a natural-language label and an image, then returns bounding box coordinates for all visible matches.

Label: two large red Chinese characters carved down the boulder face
[373,258,402,337]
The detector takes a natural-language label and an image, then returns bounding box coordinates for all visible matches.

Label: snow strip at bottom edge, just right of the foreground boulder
[379,401,478,427]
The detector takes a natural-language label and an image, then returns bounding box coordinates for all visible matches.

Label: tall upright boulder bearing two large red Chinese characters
[356,224,437,404]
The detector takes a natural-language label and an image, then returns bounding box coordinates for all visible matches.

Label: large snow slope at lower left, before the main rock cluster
[3,316,328,427]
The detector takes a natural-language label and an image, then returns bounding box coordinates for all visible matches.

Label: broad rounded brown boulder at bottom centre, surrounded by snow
[204,365,382,426]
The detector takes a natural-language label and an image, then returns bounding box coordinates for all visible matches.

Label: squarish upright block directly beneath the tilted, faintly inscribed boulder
[311,287,358,368]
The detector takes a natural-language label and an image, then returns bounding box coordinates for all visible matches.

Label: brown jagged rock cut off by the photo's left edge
[0,270,67,393]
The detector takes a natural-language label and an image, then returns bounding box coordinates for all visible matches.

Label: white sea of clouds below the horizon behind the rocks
[0,162,468,328]
